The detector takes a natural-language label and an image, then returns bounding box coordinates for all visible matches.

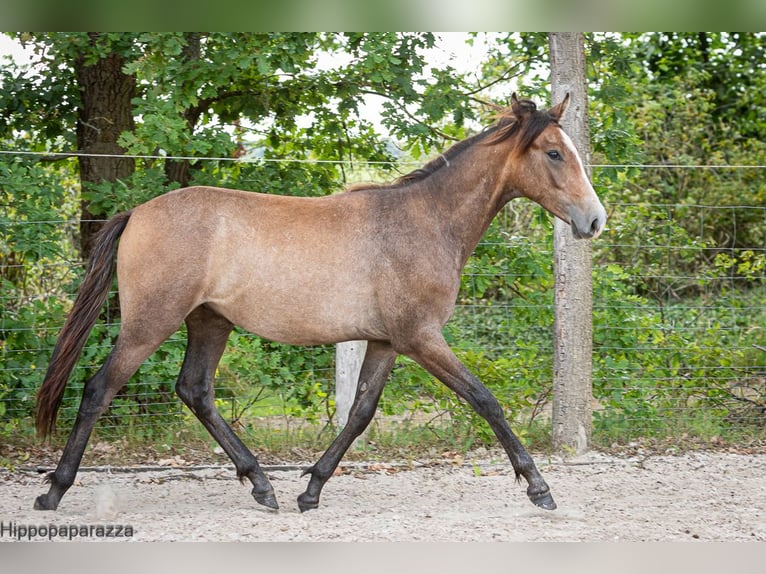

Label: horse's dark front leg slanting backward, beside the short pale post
[298,341,396,512]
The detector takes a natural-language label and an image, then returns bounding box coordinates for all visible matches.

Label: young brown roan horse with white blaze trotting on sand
[35,94,606,511]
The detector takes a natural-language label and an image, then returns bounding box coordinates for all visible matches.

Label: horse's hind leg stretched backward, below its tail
[35,330,172,510]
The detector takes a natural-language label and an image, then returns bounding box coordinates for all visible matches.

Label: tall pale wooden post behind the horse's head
[548,32,593,454]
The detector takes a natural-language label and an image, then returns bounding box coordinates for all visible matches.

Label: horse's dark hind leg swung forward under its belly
[176,305,279,510]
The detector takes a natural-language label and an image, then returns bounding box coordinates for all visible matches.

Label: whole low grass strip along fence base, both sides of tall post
[0,413,766,476]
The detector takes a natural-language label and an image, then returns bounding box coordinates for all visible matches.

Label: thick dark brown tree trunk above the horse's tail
[75,33,136,260]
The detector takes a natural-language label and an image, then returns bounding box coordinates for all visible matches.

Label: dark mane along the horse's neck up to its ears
[346,100,558,191]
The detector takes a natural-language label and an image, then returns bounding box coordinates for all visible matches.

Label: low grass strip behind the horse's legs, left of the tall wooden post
[0,410,550,468]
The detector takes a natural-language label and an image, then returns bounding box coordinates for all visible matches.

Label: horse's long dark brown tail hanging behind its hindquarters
[37,211,131,438]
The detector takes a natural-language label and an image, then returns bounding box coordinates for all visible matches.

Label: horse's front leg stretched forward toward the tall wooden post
[407,331,556,510]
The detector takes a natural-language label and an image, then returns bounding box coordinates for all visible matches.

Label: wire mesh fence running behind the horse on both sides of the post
[0,162,766,441]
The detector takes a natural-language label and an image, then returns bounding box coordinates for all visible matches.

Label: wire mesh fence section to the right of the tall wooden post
[594,200,766,434]
